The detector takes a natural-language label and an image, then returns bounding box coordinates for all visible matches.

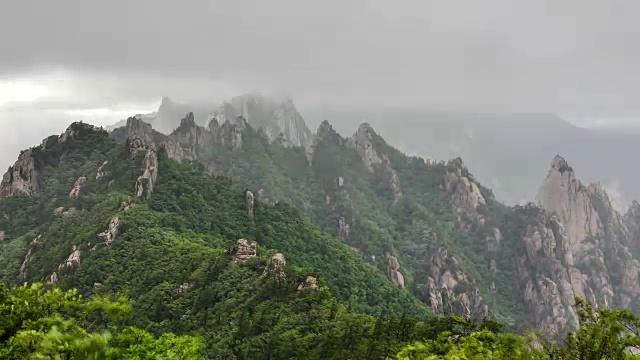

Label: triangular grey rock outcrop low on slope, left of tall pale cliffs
[422,247,489,319]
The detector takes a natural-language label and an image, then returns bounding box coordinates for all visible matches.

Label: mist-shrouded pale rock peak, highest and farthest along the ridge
[213,94,313,146]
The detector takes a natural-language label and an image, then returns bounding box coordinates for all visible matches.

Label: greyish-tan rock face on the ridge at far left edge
[0,149,38,199]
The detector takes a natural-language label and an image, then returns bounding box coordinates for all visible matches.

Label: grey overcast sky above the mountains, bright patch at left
[0,0,640,165]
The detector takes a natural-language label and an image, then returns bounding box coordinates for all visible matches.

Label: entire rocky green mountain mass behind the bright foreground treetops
[0,113,640,359]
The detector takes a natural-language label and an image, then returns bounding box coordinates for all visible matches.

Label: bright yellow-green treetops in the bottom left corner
[0,283,204,359]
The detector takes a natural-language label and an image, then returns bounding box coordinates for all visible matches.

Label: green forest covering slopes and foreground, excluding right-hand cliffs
[0,122,640,360]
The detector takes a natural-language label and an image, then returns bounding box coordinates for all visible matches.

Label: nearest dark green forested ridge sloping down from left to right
[0,118,436,358]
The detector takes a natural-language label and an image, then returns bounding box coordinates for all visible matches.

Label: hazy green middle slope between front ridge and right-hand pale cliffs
[114,114,519,323]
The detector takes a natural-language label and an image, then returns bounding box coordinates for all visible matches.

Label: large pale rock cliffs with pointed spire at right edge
[514,156,640,334]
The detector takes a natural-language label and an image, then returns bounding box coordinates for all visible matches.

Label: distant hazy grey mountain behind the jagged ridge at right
[302,107,640,211]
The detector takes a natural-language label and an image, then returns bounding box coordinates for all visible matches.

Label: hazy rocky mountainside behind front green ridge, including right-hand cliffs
[119,115,638,334]
